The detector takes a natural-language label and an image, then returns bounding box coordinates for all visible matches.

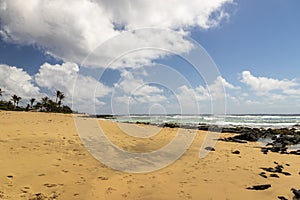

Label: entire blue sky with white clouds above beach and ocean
[0,0,300,114]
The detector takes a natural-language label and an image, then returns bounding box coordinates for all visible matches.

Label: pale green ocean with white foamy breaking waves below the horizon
[115,114,300,128]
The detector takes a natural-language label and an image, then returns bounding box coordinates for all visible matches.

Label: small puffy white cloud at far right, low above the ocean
[241,71,298,95]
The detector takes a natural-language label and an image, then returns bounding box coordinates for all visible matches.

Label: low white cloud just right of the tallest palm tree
[35,63,111,113]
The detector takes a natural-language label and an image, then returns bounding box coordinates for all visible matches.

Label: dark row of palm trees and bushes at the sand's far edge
[0,88,72,113]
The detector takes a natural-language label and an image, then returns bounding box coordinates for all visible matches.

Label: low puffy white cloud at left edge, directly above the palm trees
[0,64,40,100]
